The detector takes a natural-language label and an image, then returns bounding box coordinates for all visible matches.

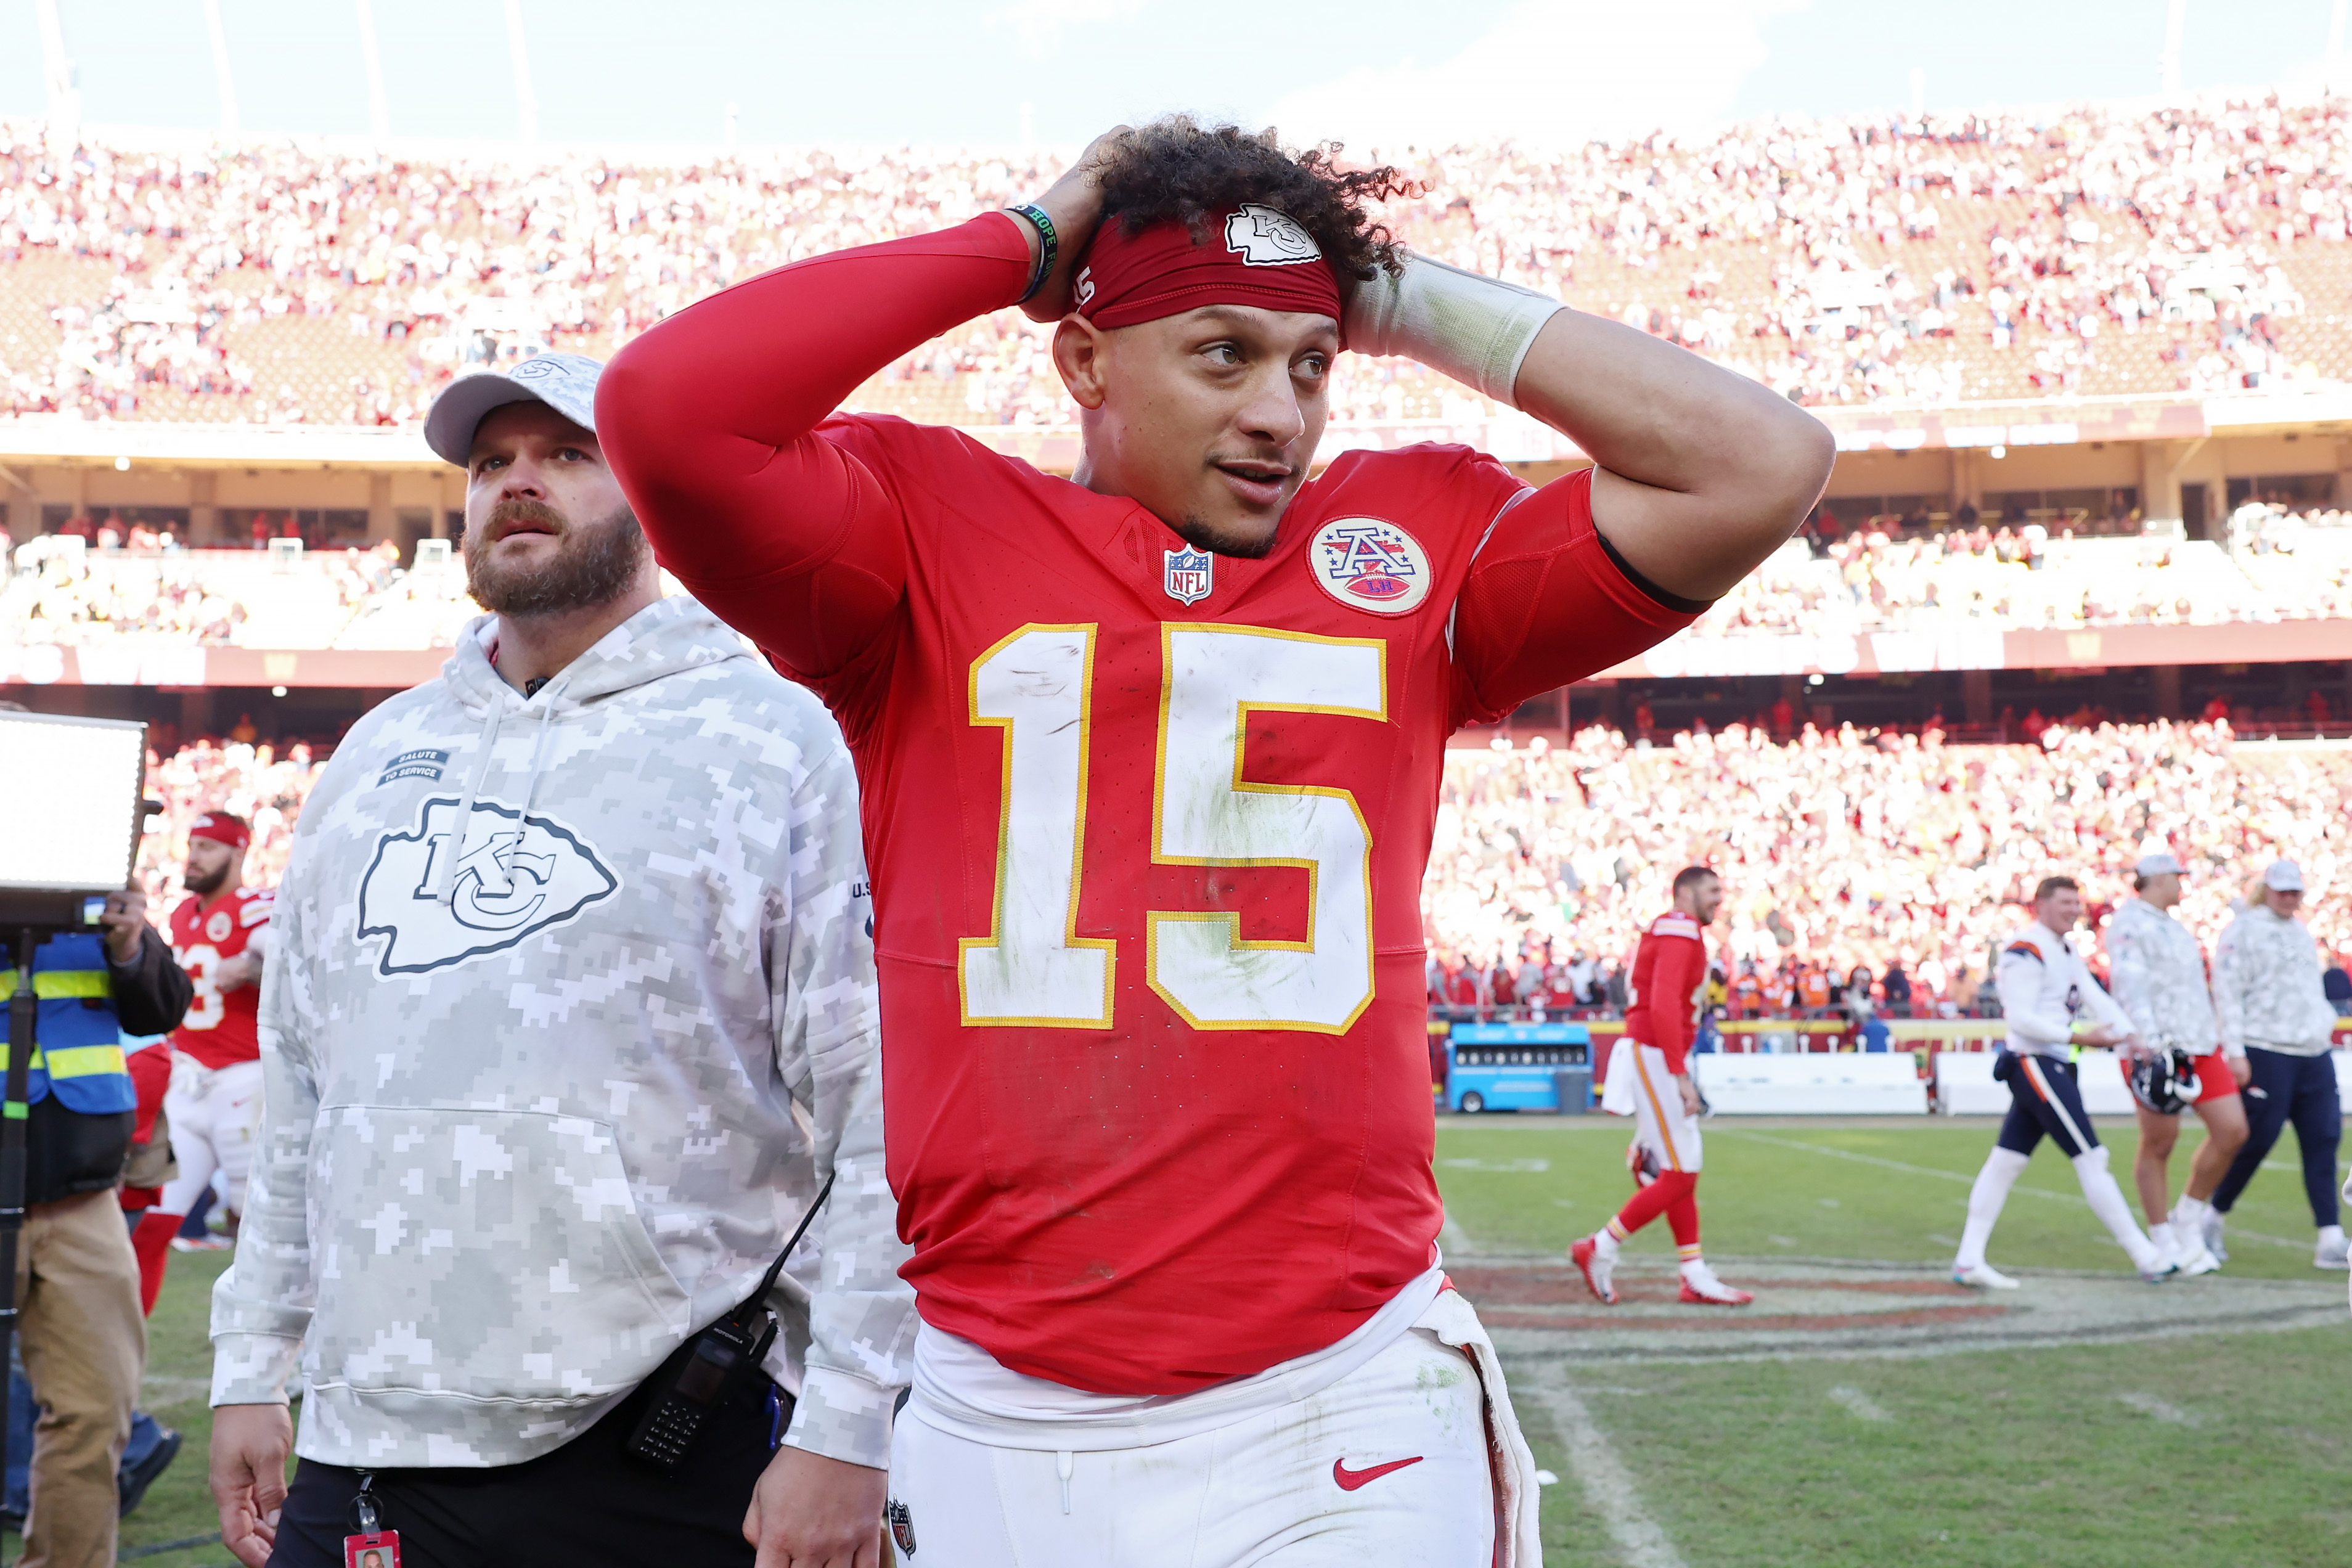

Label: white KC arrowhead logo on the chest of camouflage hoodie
[360,797,621,976]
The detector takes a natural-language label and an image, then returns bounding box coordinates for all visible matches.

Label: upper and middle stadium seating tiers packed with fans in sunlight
[14,99,2352,710]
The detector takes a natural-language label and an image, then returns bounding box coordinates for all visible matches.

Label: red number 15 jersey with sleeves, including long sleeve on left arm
[597,214,1691,1394]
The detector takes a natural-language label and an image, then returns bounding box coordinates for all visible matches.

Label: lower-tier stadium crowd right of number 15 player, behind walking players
[1423,722,2352,1016]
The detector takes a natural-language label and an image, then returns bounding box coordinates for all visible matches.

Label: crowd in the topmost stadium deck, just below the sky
[0,96,2352,423]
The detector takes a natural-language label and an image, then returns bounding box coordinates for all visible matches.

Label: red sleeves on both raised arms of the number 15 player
[597,211,1705,705]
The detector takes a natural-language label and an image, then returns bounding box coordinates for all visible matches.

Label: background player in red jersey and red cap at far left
[132,811,275,1286]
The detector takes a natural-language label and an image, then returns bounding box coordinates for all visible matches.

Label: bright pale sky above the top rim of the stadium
[0,0,2338,145]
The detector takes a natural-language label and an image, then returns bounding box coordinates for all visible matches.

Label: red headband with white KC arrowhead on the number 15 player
[1077,202,1341,327]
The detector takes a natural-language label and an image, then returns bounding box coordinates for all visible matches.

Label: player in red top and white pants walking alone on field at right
[1569,865,1755,1307]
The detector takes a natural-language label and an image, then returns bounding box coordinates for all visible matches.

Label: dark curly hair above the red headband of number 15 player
[1093,115,1418,294]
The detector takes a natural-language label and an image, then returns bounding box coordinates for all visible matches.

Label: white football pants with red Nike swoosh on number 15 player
[889,1296,1533,1568]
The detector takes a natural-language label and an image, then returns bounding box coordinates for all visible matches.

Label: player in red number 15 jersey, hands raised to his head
[597,120,1832,1566]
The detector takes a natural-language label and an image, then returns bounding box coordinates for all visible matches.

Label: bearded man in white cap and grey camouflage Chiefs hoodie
[211,355,915,1568]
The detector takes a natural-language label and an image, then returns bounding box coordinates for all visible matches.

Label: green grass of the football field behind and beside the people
[32,1117,2352,1568]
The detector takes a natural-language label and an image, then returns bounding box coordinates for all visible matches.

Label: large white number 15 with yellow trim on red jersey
[957,623,1387,1034]
